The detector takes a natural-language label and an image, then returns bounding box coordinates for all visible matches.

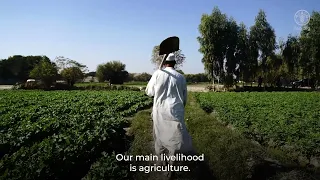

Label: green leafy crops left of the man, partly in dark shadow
[0,91,152,179]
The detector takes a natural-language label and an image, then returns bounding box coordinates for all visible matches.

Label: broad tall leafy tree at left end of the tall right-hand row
[198,7,240,87]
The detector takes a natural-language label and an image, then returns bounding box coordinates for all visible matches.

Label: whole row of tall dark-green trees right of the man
[197,7,320,86]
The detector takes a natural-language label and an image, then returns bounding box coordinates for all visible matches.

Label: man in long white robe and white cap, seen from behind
[145,53,193,176]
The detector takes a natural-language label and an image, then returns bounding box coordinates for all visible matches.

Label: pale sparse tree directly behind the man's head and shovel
[151,45,186,68]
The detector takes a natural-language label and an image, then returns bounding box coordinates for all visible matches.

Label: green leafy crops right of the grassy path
[196,92,320,159]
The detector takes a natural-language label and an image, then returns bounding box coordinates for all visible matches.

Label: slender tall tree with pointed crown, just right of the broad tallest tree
[250,10,276,87]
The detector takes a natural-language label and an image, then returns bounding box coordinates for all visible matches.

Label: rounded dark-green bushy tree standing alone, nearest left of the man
[96,61,129,84]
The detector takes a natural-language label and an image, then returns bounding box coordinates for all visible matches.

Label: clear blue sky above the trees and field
[0,0,320,74]
